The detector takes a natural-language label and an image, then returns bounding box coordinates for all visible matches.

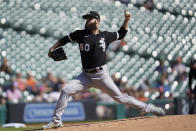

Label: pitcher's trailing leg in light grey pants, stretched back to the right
[92,70,165,116]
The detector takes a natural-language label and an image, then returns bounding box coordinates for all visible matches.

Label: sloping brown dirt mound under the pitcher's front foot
[48,115,196,131]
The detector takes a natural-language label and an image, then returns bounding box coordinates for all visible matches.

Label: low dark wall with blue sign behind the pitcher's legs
[0,98,194,124]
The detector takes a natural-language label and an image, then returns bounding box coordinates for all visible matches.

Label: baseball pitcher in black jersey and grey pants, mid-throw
[43,11,165,129]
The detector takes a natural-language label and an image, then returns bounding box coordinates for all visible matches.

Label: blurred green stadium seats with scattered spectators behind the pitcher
[0,0,196,129]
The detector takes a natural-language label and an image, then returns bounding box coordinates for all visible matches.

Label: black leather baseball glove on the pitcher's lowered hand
[50,47,67,61]
